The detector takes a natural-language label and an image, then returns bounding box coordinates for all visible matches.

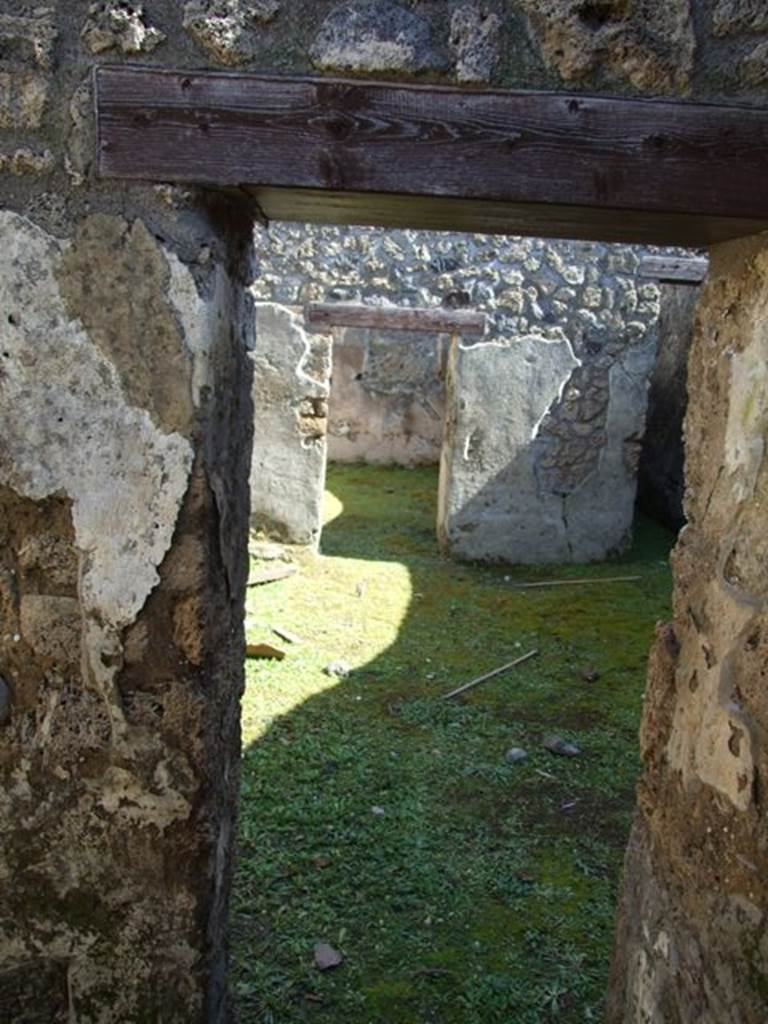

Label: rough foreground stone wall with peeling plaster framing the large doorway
[0,0,768,1024]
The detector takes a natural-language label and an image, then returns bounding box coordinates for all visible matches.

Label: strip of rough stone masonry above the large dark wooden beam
[54,0,768,108]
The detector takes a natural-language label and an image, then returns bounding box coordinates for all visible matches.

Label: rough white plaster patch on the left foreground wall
[0,211,193,637]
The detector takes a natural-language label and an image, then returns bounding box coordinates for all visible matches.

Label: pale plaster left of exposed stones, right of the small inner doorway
[438,335,579,562]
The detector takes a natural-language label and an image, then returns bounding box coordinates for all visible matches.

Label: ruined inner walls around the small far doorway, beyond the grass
[251,223,702,563]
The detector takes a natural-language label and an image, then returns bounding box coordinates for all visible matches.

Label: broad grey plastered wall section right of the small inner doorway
[438,327,655,563]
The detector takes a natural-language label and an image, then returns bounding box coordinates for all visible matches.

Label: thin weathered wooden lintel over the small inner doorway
[307,302,485,334]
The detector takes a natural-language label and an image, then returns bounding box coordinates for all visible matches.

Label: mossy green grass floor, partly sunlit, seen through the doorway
[232,467,671,1024]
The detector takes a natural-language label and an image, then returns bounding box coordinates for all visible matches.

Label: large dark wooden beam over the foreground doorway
[95,67,768,245]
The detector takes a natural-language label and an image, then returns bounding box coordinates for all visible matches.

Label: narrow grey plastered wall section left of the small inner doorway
[251,302,331,547]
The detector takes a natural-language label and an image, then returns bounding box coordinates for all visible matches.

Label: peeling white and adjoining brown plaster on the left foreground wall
[0,212,204,714]
